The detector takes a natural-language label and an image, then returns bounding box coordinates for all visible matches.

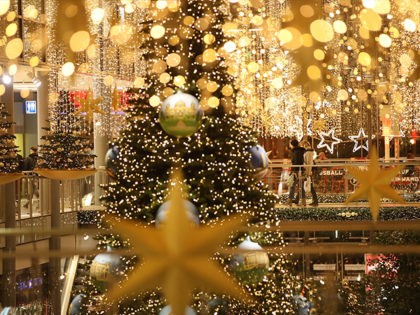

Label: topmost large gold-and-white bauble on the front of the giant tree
[159,92,203,138]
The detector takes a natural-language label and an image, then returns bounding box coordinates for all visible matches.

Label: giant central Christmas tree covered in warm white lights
[75,0,293,314]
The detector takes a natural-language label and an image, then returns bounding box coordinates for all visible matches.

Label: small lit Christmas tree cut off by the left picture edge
[0,103,21,174]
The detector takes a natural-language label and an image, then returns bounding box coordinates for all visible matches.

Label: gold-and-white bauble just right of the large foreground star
[231,236,270,283]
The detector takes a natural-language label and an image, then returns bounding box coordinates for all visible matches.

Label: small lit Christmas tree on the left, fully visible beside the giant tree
[37,91,94,170]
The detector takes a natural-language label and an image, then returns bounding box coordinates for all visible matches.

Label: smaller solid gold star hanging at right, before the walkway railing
[345,148,404,222]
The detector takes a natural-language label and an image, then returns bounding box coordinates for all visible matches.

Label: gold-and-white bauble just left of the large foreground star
[90,253,122,292]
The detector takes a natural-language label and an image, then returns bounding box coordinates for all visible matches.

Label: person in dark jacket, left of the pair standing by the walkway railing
[287,139,306,206]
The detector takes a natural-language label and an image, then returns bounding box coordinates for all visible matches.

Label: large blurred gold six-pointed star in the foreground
[107,171,249,315]
